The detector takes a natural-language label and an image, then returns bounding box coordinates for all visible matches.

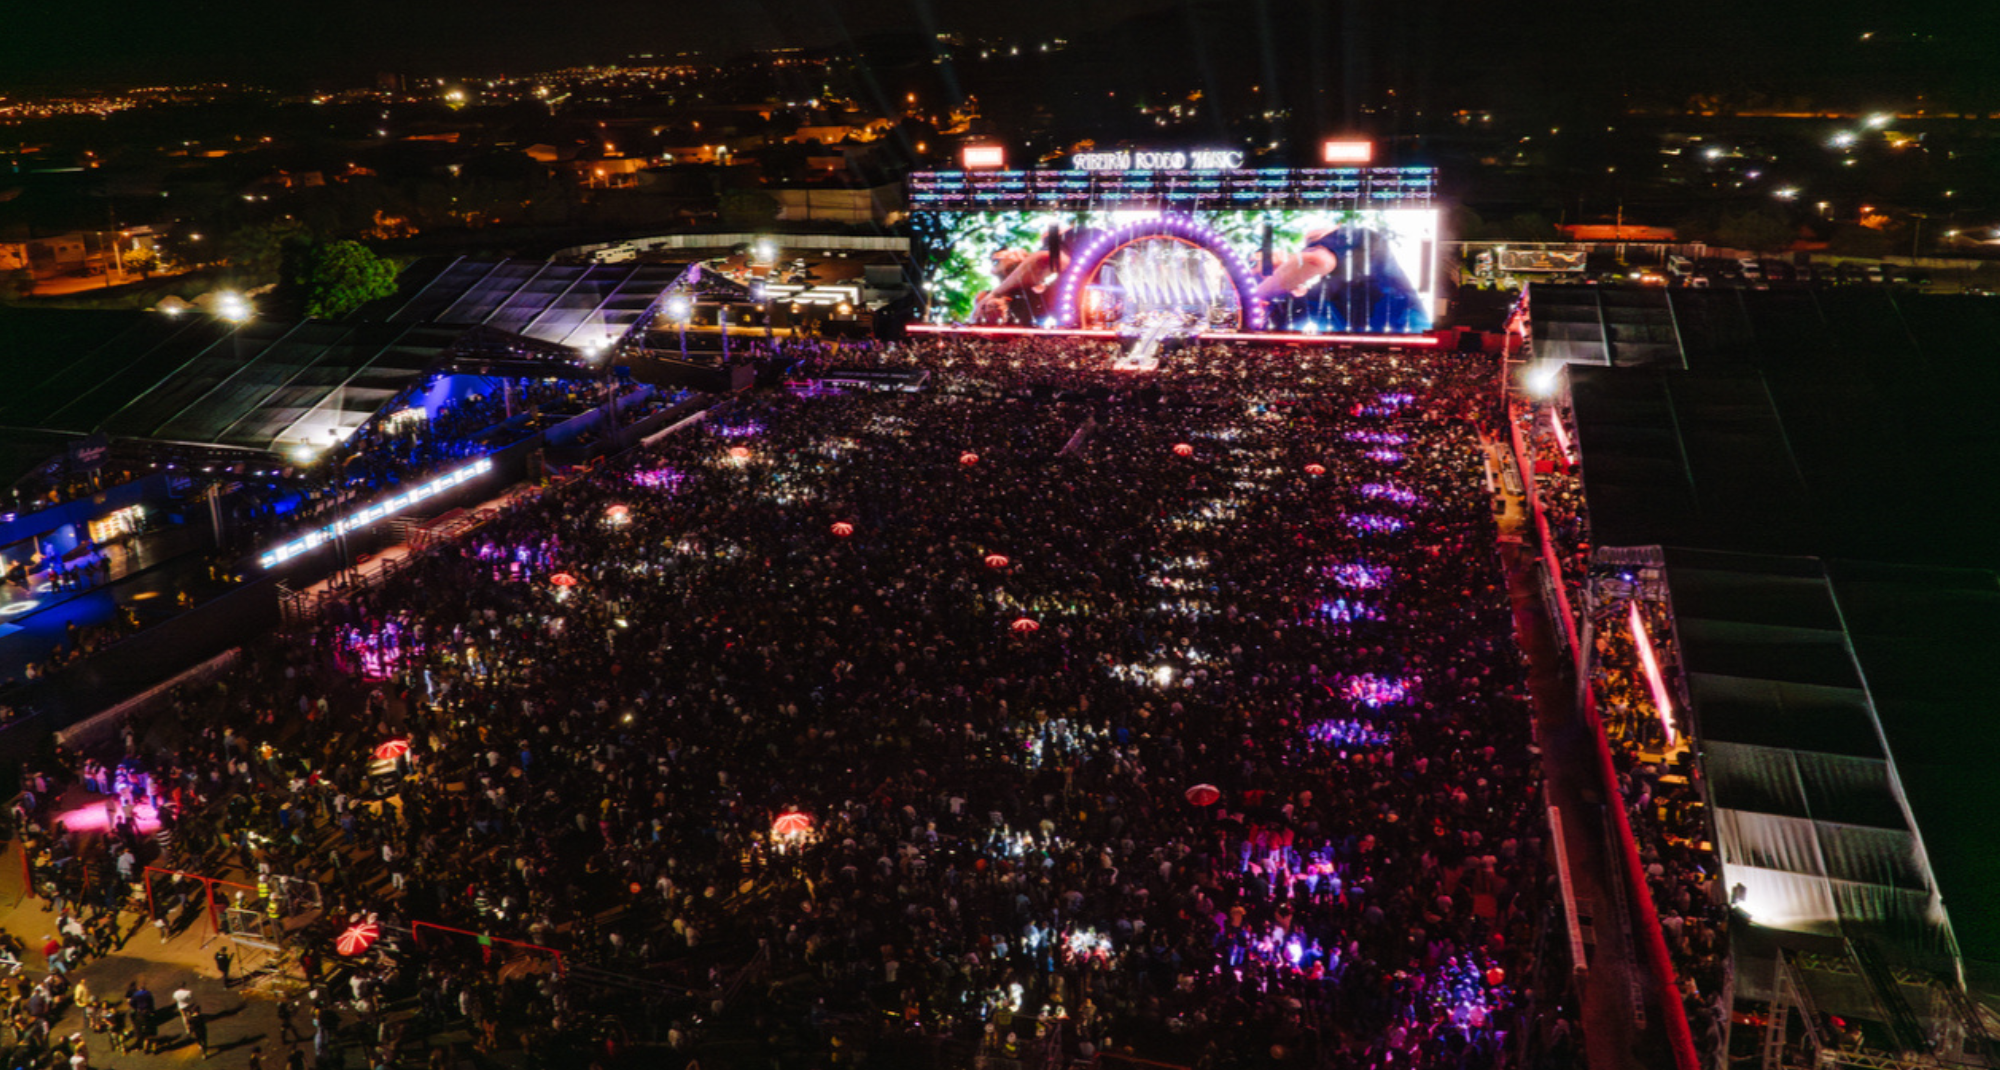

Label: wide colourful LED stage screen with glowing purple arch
[912,208,1438,334]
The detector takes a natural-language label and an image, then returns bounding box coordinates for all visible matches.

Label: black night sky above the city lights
[0,0,2000,96]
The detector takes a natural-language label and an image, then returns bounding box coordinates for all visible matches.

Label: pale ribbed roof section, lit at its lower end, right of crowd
[1666,550,1958,972]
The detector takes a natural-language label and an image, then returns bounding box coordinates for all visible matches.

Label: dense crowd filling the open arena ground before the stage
[20,340,1580,1070]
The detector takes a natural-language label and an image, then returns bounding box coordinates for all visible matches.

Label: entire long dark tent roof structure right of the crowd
[1530,286,2000,1066]
